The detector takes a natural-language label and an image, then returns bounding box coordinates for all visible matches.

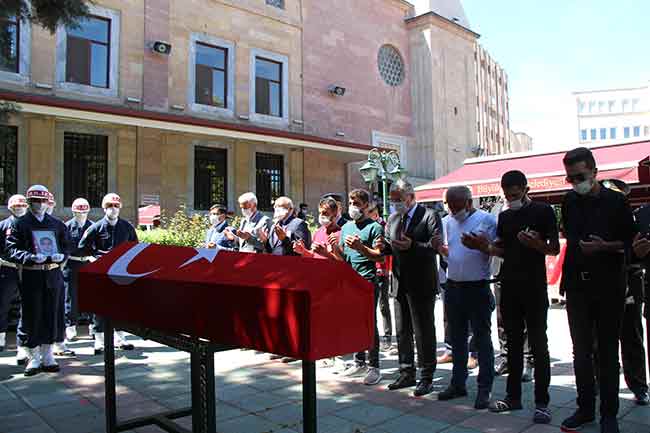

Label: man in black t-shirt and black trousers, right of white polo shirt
[466,171,560,424]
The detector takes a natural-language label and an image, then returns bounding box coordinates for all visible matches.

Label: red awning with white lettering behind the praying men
[415,141,650,202]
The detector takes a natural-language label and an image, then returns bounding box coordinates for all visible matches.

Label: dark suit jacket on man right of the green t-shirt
[385,205,440,294]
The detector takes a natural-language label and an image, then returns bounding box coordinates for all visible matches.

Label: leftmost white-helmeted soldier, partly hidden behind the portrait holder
[0,194,27,352]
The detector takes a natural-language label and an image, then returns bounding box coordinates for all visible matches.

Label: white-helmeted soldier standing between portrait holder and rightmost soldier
[63,198,94,341]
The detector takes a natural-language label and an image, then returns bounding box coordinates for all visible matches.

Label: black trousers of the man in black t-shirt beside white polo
[500,281,551,406]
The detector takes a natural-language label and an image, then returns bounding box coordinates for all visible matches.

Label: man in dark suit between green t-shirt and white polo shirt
[378,180,440,396]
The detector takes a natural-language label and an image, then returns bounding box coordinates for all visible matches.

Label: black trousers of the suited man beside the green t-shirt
[395,286,436,380]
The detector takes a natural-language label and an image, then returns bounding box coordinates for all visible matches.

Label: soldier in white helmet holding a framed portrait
[6,185,70,376]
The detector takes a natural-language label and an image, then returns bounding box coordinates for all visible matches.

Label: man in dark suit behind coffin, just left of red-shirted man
[262,197,311,256]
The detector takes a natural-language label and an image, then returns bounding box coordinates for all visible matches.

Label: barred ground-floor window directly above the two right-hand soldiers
[63,132,108,207]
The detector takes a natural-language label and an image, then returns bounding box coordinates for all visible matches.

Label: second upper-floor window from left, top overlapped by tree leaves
[65,17,111,88]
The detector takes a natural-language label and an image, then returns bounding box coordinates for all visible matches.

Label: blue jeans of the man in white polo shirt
[445,281,496,391]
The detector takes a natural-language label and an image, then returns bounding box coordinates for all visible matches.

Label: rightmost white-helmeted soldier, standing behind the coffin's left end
[78,193,138,355]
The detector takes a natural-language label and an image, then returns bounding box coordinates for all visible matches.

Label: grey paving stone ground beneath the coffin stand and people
[0,305,650,433]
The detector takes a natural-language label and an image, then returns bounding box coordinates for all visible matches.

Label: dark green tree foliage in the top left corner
[0,0,92,123]
